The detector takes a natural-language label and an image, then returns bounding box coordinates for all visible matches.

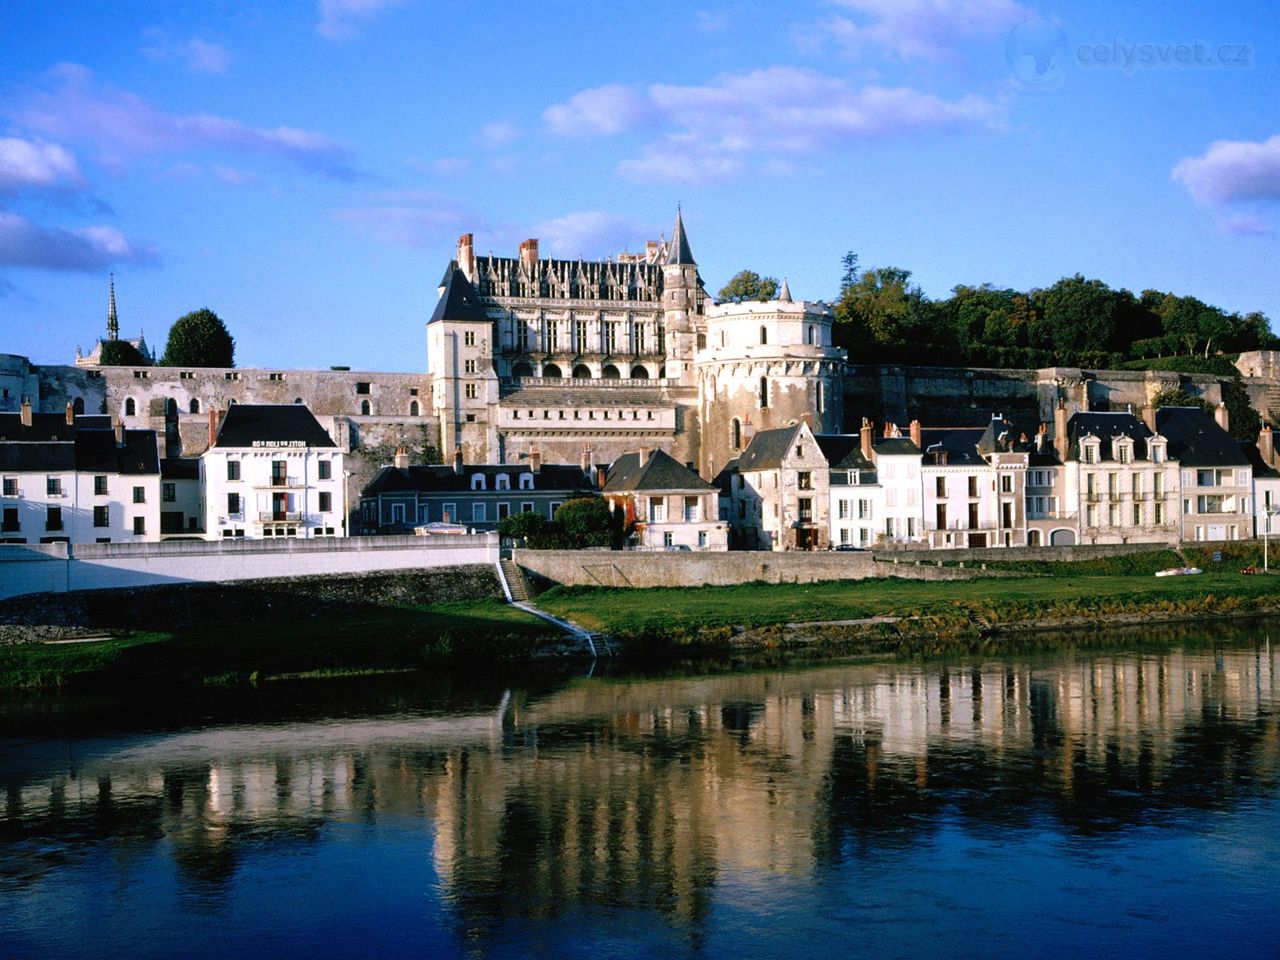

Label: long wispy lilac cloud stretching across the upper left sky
[14,64,357,179]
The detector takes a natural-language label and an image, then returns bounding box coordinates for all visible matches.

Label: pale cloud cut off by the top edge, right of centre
[819,0,1033,60]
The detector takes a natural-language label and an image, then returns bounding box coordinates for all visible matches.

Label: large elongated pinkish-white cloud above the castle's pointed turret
[544,67,1005,183]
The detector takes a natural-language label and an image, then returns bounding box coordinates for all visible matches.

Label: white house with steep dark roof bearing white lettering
[200,403,347,539]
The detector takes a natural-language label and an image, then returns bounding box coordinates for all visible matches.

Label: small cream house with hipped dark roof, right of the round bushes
[603,449,728,550]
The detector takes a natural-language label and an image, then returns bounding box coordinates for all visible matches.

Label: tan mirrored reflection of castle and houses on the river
[0,649,1280,929]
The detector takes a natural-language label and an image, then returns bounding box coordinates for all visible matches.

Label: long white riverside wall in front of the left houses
[0,534,498,599]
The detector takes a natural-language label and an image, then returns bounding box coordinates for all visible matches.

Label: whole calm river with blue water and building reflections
[0,628,1280,960]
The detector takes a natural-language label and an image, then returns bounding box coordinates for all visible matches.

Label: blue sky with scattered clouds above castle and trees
[0,0,1280,371]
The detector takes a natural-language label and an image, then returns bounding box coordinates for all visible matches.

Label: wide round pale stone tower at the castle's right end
[696,289,847,476]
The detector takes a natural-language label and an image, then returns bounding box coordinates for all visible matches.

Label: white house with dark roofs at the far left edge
[0,401,161,543]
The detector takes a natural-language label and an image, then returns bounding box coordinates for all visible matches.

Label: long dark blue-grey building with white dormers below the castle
[360,449,595,534]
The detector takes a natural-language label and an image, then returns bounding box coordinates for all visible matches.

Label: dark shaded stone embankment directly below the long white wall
[0,564,502,645]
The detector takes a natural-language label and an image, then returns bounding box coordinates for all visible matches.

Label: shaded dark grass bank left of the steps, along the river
[0,599,557,690]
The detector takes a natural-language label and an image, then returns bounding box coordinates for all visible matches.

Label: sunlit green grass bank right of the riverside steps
[538,572,1280,643]
